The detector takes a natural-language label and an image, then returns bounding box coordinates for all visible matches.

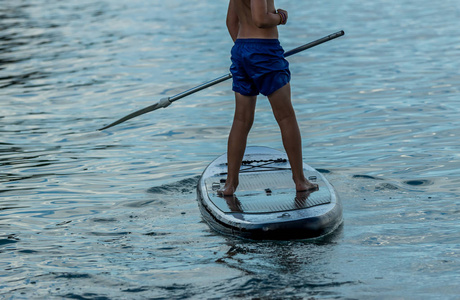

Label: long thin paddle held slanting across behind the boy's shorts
[98,30,345,130]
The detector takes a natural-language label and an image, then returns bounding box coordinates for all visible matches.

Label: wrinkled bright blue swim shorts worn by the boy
[230,39,291,96]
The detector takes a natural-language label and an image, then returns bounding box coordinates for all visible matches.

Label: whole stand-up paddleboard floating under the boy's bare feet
[197,147,342,239]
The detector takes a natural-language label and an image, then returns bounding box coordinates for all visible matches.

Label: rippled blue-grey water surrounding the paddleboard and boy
[0,0,460,299]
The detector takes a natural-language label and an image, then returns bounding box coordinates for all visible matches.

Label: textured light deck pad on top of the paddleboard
[205,168,331,214]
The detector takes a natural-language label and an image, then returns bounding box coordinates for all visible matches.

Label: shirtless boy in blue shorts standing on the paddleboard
[218,0,318,196]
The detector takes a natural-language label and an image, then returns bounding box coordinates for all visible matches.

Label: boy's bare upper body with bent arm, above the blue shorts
[227,0,287,40]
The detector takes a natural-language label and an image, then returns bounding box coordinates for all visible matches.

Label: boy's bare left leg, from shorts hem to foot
[217,93,257,196]
